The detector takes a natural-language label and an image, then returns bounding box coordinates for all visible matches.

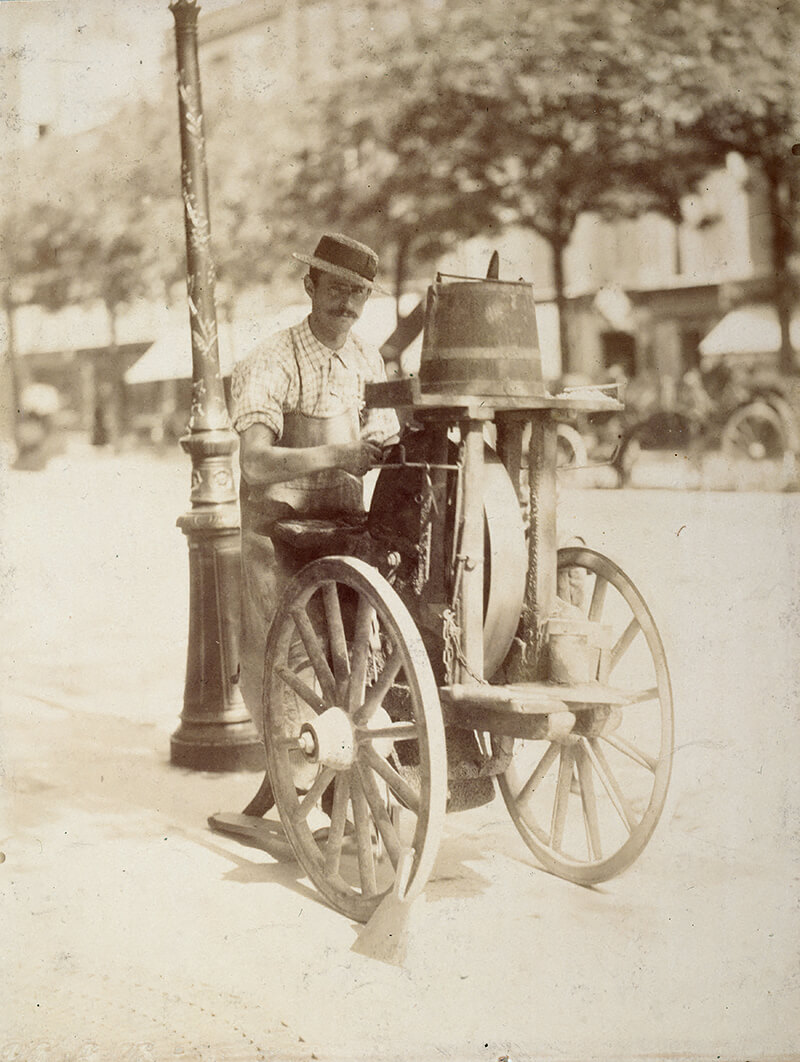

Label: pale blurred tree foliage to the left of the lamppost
[2,104,180,321]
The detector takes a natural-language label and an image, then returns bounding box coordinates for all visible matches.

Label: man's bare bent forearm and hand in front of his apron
[239,424,380,486]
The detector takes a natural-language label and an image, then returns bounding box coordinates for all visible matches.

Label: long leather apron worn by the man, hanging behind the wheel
[240,344,363,733]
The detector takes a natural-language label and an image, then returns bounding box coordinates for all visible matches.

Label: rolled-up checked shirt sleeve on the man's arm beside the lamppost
[231,335,291,440]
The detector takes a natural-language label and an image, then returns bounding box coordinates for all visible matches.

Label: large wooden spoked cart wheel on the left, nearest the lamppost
[265,556,447,922]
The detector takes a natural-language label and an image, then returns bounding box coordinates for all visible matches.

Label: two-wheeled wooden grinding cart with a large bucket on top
[215,267,673,922]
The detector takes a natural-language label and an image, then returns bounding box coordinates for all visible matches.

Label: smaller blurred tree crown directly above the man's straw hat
[287,3,497,310]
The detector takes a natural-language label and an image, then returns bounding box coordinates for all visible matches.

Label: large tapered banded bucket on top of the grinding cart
[420,279,545,398]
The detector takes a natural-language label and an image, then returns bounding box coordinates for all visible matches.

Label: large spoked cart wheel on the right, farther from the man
[498,547,673,885]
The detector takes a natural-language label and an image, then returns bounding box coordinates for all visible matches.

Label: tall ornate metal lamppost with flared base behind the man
[170,0,265,771]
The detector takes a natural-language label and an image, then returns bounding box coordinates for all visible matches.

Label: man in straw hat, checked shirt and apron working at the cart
[232,234,399,730]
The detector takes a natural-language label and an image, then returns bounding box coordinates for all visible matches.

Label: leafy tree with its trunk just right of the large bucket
[376,0,701,371]
